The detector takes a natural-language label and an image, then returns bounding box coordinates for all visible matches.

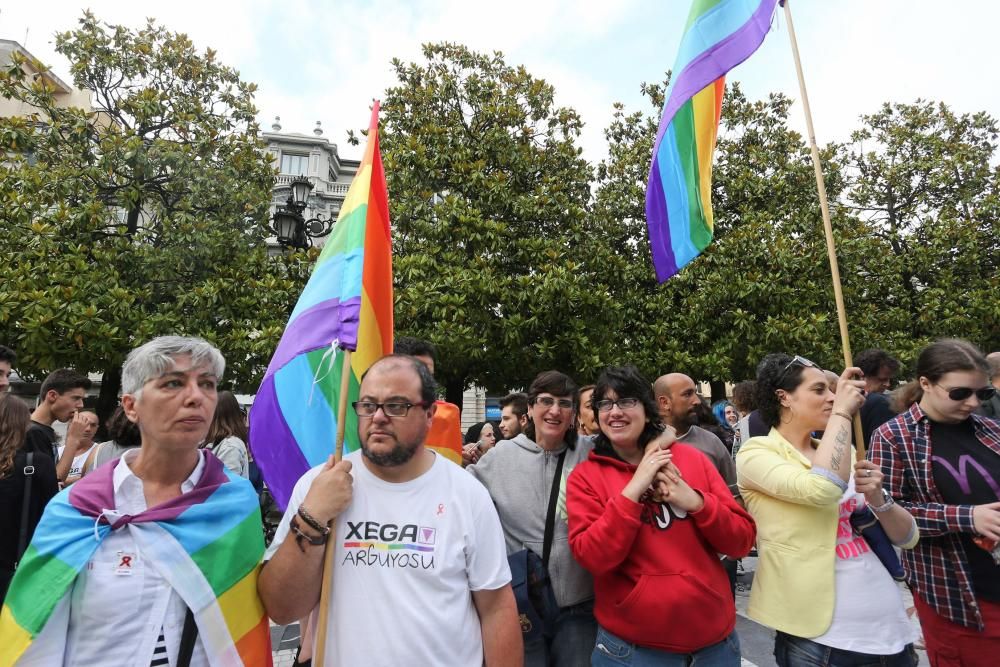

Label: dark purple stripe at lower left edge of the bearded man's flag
[250,375,310,510]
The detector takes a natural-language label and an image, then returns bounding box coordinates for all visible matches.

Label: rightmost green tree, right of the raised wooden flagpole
[842,100,1000,360]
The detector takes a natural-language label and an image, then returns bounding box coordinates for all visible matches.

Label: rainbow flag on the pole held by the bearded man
[250,102,393,508]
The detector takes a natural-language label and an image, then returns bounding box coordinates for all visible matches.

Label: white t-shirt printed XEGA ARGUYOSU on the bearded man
[264,452,510,667]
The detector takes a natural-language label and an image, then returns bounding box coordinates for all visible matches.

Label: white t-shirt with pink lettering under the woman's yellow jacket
[812,475,916,655]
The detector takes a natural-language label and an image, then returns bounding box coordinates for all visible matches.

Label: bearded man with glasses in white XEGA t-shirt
[258,355,523,667]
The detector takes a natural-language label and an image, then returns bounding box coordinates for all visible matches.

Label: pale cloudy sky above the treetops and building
[7,0,1000,162]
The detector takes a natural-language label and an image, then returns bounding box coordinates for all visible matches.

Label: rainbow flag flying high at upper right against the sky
[646,0,777,283]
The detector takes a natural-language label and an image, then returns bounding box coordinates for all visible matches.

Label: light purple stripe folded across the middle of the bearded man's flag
[265,296,361,377]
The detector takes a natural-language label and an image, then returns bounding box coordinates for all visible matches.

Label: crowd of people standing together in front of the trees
[0,336,1000,667]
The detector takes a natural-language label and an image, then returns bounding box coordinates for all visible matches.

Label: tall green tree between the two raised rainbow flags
[382,44,620,402]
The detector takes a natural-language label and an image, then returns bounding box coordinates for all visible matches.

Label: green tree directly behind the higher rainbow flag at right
[594,84,859,392]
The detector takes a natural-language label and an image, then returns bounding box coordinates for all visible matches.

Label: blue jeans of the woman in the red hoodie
[590,628,740,667]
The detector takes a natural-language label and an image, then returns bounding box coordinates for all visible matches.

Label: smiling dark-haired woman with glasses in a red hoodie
[566,366,756,667]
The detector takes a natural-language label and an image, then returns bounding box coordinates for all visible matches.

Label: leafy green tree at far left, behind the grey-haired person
[0,13,308,422]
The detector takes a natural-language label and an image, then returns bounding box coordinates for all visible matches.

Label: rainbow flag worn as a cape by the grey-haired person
[0,452,272,667]
